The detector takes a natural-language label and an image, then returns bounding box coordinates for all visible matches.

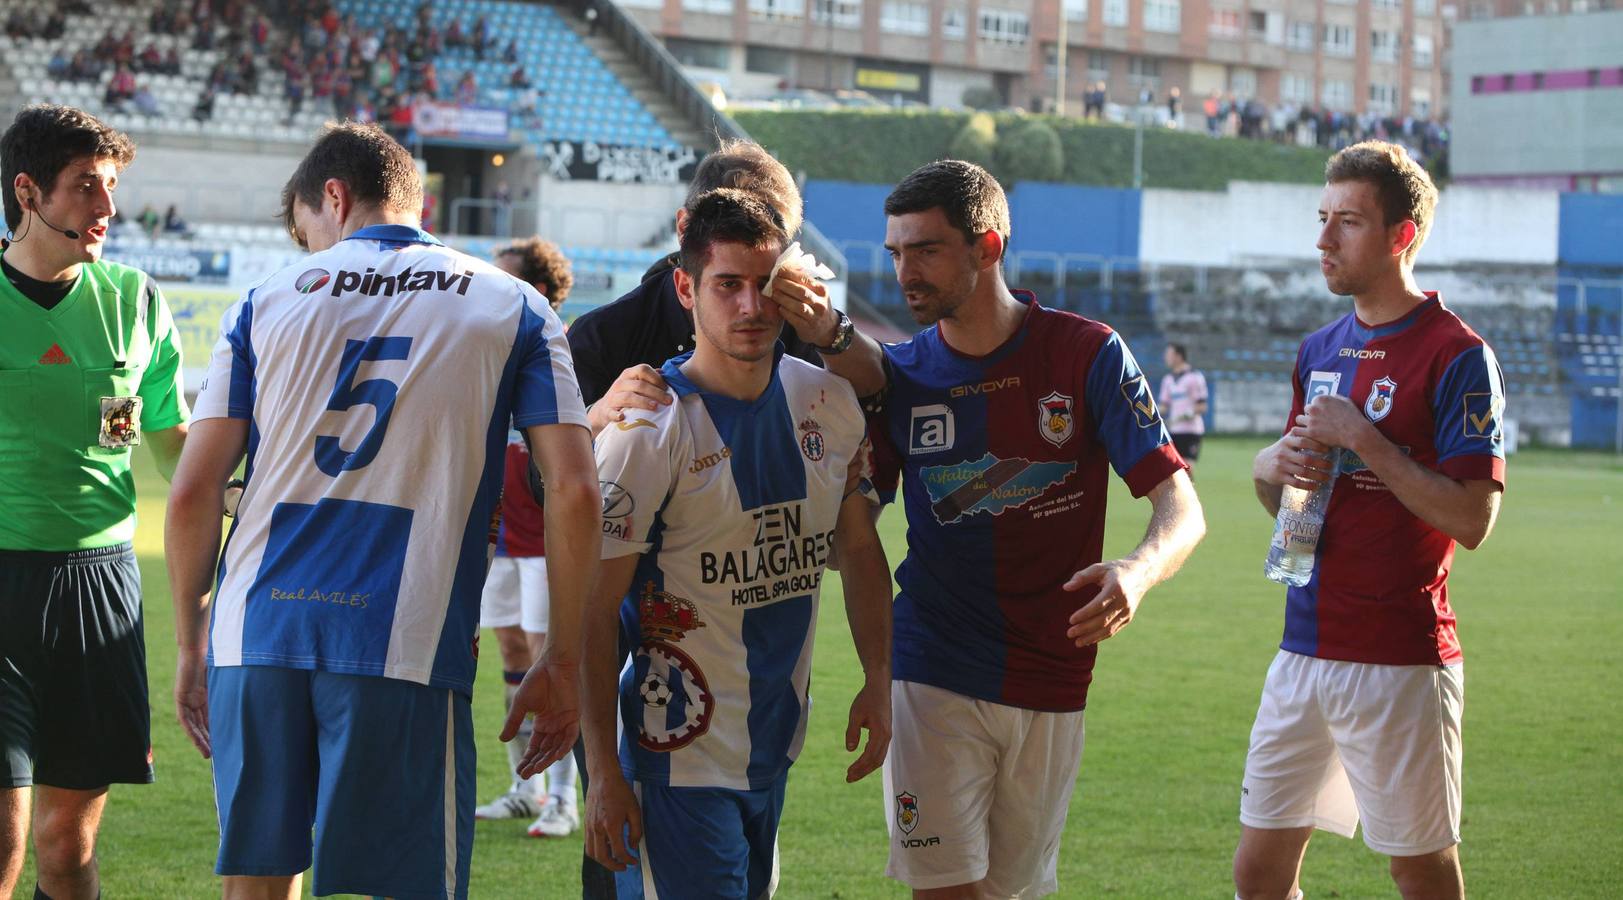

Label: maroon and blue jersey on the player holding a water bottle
[1281,292,1505,665]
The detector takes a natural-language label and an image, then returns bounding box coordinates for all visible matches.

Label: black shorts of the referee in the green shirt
[0,543,153,790]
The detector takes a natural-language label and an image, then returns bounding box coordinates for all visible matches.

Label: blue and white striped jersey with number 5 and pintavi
[195,225,586,692]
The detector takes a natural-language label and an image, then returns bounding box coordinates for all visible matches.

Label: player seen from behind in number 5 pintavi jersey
[166,125,601,897]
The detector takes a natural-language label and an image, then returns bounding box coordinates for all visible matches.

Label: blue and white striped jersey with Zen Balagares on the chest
[596,347,863,790]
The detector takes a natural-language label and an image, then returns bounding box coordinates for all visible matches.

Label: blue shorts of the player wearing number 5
[208,665,476,900]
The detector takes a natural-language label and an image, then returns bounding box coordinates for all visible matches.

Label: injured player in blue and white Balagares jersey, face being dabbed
[583,188,891,900]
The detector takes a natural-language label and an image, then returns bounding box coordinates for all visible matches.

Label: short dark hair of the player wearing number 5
[282,122,422,240]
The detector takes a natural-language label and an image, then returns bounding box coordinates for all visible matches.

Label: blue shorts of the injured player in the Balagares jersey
[615,772,789,900]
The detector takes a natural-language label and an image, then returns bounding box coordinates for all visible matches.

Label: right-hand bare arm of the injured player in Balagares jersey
[834,467,891,782]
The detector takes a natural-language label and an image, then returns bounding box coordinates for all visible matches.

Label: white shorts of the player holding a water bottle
[1240,650,1466,856]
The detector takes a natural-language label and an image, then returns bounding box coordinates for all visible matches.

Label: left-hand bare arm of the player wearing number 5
[154,418,248,759]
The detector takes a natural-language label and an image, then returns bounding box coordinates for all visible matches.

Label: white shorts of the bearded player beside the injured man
[885,681,1083,897]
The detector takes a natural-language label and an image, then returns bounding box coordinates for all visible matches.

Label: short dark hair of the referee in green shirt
[0,104,135,229]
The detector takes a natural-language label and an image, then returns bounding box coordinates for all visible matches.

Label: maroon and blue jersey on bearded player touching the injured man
[868,290,1185,710]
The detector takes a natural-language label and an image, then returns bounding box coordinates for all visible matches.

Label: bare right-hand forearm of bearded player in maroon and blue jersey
[1065,469,1206,647]
